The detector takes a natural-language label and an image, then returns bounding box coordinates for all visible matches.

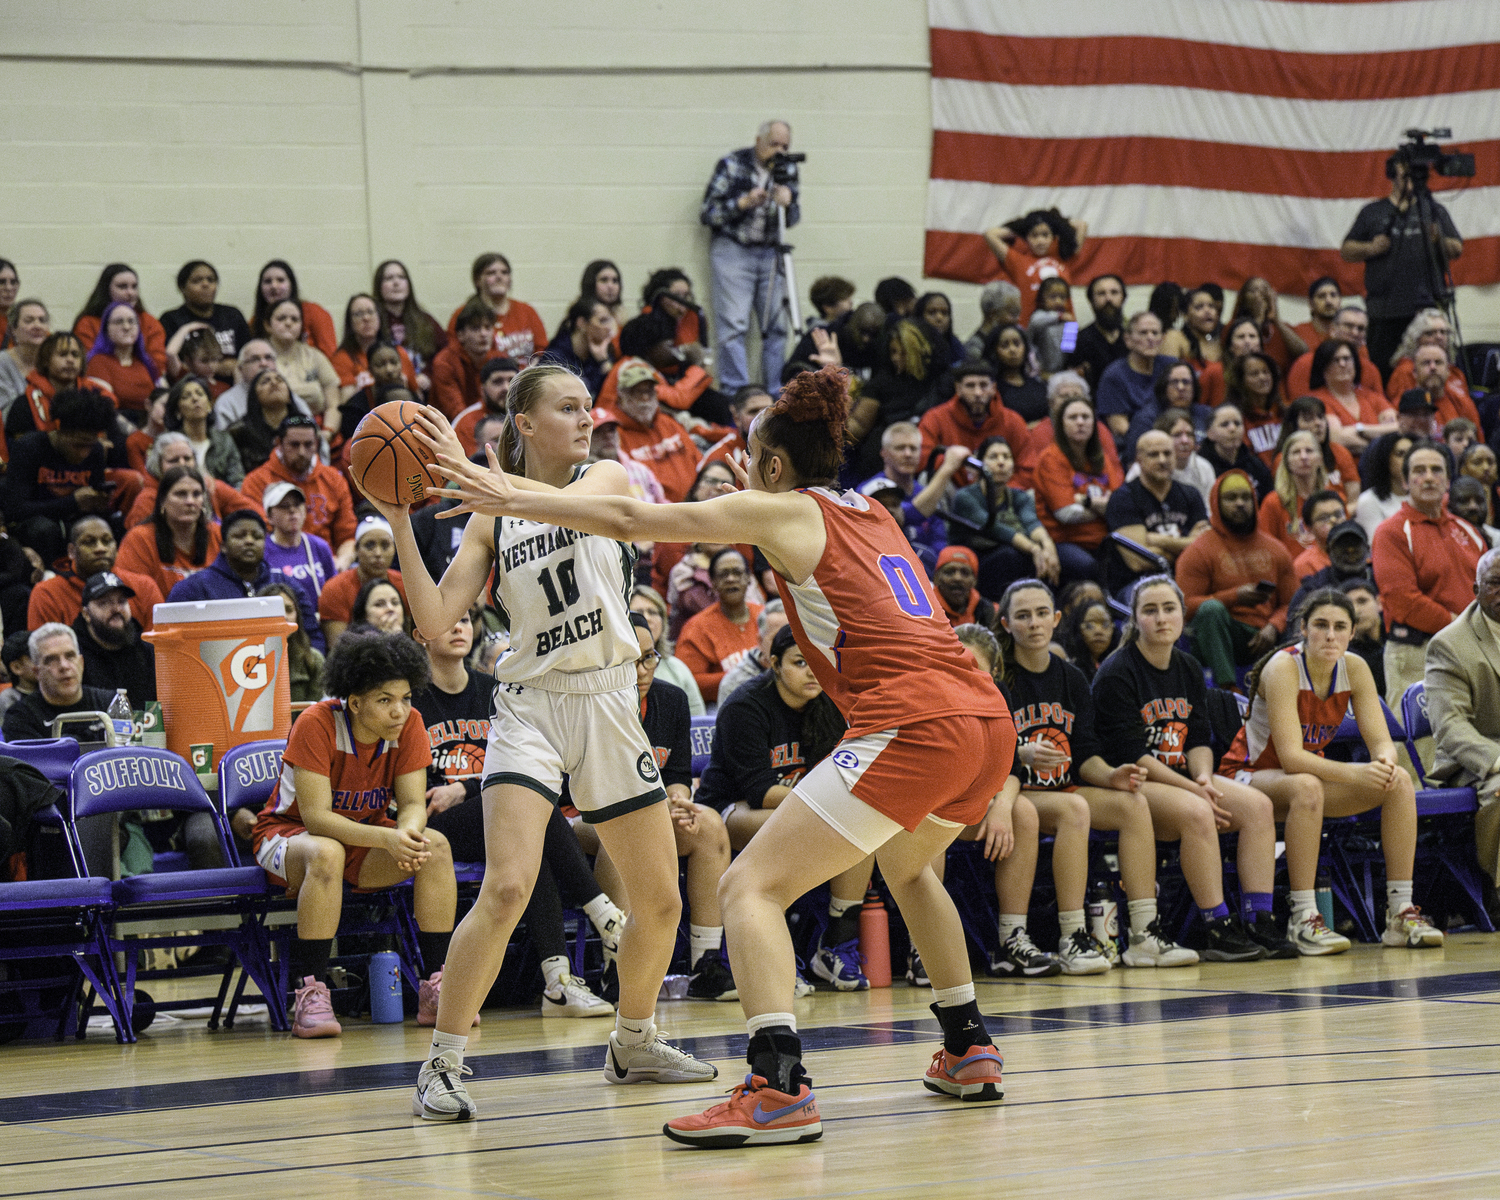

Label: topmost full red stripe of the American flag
[932,29,1496,102]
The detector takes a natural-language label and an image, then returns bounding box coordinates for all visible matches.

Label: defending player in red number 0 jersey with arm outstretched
[434,368,1016,1149]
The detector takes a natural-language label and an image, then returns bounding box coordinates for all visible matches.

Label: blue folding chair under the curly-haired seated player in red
[219,740,429,1002]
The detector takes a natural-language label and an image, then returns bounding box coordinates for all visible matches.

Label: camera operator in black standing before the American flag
[1338,146,1464,383]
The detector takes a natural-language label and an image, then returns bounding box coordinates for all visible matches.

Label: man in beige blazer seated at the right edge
[1427,551,1500,881]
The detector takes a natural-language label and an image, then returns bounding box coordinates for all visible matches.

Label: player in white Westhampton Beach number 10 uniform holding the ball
[360,366,719,1121]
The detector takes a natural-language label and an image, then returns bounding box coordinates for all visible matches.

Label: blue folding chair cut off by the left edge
[0,750,135,1043]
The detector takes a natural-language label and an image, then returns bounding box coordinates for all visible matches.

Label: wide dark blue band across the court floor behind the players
[0,972,1500,1125]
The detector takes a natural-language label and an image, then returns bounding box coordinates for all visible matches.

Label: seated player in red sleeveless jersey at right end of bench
[1218,588,1443,954]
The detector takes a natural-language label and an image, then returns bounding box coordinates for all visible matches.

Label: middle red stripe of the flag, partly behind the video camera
[932,129,1500,198]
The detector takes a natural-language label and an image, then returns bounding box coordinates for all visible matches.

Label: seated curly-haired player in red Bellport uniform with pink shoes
[251,633,458,1038]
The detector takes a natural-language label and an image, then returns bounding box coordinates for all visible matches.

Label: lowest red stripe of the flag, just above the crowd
[923,230,1500,296]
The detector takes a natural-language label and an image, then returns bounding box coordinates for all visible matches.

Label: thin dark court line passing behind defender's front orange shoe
[11,1071,1500,1200]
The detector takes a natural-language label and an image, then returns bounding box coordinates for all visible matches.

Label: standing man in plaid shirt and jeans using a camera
[699,120,801,393]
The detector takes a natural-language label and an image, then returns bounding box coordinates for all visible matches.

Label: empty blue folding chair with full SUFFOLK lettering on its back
[69,746,290,1031]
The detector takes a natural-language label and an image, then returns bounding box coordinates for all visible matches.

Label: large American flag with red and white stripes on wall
[926,0,1500,294]
